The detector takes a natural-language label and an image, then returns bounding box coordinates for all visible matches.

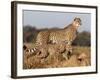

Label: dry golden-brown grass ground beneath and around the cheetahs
[23,43,91,69]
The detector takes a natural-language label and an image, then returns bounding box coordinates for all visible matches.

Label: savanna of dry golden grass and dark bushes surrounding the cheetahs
[23,26,91,69]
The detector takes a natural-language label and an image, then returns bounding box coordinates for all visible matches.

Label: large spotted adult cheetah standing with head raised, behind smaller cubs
[24,18,81,55]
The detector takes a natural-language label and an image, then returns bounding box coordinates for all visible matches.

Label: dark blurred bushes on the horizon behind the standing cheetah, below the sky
[23,25,91,46]
